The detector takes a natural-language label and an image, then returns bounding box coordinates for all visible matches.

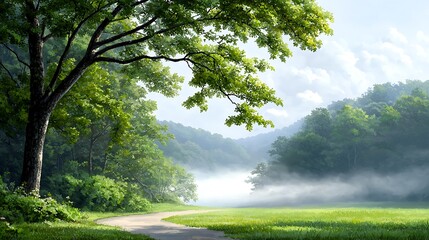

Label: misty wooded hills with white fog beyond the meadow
[160,81,429,206]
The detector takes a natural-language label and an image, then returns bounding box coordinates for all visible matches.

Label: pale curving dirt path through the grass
[96,210,231,240]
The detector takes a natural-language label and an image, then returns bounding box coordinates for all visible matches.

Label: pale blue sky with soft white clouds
[150,0,429,139]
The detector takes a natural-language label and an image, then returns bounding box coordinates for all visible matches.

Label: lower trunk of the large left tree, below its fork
[21,106,50,192]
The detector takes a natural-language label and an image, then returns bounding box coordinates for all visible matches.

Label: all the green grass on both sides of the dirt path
[5,204,429,240]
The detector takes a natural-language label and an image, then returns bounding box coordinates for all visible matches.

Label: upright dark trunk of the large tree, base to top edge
[21,0,47,192]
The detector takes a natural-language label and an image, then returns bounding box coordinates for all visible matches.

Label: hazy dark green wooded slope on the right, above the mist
[250,81,429,198]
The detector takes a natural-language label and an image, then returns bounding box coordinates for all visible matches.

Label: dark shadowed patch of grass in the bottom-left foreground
[6,221,154,240]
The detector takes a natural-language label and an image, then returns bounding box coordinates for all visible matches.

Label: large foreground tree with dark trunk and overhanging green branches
[0,0,332,191]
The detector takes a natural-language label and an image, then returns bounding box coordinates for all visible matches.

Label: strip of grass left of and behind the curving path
[0,203,204,240]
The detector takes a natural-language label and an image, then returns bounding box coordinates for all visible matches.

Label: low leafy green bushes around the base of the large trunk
[0,176,81,223]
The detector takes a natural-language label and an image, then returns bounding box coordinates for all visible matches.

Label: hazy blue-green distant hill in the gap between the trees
[159,121,302,171]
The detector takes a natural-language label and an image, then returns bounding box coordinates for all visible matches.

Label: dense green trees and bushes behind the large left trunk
[0,63,196,211]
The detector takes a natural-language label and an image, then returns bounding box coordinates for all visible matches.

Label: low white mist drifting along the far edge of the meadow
[190,168,429,207]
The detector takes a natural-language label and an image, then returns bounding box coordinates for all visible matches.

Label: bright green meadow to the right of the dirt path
[167,208,429,240]
